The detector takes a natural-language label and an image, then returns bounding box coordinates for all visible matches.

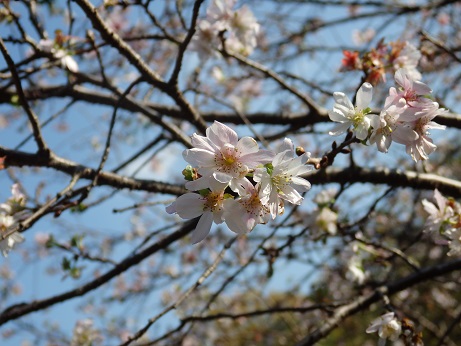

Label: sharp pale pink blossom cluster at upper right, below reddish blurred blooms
[328,68,447,161]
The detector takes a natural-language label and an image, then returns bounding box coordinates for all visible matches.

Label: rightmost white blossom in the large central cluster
[253,138,312,219]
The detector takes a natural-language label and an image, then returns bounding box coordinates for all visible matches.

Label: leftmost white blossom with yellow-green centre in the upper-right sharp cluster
[328,83,373,140]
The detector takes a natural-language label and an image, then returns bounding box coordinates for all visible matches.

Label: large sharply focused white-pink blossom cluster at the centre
[166,121,312,243]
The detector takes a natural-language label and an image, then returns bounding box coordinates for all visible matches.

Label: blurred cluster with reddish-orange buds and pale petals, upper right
[341,40,421,85]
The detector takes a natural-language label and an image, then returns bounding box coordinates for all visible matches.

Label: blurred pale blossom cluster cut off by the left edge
[0,184,26,257]
